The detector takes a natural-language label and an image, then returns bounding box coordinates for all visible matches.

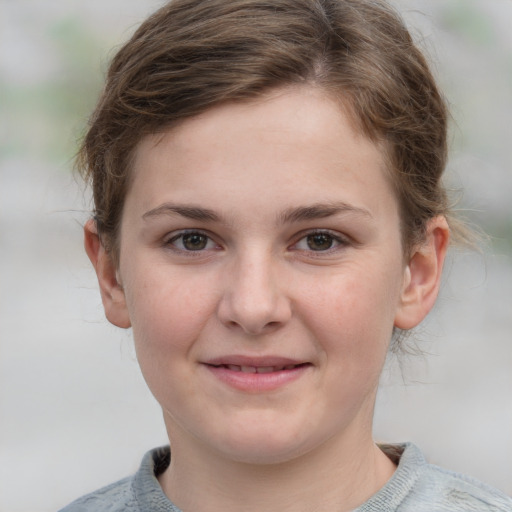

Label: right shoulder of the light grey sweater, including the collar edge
[370,444,512,512]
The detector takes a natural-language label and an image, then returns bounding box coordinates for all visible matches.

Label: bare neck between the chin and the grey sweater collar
[160,424,395,512]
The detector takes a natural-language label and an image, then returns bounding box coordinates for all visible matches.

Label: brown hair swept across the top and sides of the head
[78,0,454,259]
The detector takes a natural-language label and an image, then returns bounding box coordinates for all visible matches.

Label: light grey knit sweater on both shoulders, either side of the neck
[60,444,512,512]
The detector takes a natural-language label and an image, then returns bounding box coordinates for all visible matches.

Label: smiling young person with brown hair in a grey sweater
[64,0,512,512]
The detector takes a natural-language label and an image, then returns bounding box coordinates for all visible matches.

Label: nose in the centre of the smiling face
[218,251,292,336]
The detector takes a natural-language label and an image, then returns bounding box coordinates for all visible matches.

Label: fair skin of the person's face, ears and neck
[85,87,449,512]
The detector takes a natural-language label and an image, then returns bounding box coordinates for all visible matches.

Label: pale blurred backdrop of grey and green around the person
[0,0,512,512]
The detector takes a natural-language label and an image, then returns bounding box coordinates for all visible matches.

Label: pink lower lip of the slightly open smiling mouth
[205,364,311,393]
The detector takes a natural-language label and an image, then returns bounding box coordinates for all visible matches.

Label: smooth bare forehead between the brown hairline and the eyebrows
[127,87,396,222]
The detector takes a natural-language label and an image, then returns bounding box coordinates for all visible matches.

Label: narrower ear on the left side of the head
[84,219,131,329]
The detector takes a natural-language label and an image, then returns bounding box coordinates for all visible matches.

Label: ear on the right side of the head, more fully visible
[395,216,450,330]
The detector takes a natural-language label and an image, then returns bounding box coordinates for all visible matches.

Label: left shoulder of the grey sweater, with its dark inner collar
[60,447,178,512]
